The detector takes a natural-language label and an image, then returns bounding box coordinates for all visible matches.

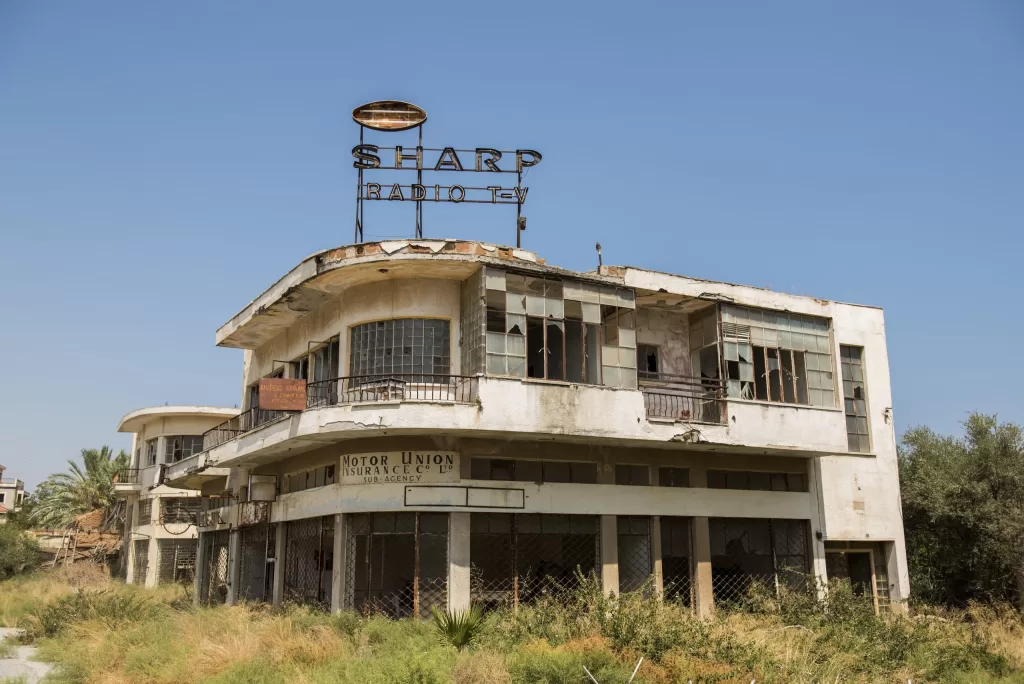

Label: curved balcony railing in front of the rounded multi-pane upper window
[306,373,477,409]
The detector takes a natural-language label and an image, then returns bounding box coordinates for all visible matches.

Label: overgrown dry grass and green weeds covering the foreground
[0,566,1024,684]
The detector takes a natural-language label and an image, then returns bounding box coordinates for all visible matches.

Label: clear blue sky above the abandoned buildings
[0,0,1024,486]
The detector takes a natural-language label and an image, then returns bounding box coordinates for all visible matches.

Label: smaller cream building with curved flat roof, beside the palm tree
[114,407,239,587]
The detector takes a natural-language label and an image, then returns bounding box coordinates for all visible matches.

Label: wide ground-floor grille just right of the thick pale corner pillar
[469,513,600,608]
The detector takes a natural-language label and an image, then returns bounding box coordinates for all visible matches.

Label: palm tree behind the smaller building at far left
[31,446,131,529]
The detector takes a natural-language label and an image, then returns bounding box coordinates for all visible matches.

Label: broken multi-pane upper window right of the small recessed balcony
[722,304,836,407]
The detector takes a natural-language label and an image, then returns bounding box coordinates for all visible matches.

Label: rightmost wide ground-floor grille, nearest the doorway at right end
[709,518,809,607]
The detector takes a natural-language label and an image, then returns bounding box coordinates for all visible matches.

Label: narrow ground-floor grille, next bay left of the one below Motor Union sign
[285,515,334,609]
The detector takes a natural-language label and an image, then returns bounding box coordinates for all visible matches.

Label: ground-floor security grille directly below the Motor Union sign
[345,513,449,617]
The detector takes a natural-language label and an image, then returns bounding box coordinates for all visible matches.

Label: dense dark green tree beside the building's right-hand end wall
[899,414,1024,609]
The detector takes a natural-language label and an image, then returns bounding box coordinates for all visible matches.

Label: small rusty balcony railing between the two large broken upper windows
[637,371,725,424]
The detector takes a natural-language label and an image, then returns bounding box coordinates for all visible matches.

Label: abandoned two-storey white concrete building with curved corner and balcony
[149,240,909,616]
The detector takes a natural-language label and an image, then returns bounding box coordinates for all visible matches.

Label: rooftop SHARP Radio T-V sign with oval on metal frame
[352,99,542,247]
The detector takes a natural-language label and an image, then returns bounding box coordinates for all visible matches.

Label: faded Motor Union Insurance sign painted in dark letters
[340,452,460,484]
